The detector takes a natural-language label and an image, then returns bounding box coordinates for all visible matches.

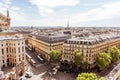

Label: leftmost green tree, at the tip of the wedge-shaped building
[50,50,62,63]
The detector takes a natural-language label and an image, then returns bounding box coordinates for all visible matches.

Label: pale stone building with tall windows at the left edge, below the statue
[0,35,25,68]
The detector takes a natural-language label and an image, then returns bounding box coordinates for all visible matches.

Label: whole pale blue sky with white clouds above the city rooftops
[0,0,120,27]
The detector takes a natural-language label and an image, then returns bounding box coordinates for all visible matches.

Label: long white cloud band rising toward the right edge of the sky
[71,2,120,23]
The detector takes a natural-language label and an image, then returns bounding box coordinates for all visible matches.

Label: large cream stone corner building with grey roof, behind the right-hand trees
[62,34,120,68]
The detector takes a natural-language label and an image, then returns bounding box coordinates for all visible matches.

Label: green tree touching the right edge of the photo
[108,46,120,62]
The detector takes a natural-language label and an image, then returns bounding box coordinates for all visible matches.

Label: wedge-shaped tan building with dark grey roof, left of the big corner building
[25,35,70,61]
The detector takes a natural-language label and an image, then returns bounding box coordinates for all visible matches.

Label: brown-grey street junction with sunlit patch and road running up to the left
[24,48,76,80]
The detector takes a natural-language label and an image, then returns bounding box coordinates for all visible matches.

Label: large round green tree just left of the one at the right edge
[96,52,111,70]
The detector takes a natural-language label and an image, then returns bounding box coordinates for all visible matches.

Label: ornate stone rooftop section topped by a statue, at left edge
[0,9,10,30]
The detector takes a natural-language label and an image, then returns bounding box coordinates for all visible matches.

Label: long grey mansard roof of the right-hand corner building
[65,33,120,45]
